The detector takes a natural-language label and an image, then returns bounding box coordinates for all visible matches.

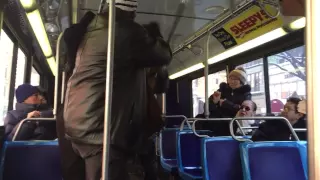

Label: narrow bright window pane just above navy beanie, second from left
[13,48,26,109]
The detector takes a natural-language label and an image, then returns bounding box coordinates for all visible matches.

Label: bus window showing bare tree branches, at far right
[268,46,306,113]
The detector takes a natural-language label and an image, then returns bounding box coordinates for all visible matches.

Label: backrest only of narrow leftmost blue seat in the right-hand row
[160,129,179,159]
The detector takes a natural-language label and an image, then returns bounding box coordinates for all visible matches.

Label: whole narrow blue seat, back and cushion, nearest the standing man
[160,128,179,173]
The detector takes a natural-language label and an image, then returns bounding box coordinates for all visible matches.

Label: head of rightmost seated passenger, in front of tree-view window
[281,97,307,124]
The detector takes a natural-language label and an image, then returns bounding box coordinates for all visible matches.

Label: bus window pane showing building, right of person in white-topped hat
[238,59,267,114]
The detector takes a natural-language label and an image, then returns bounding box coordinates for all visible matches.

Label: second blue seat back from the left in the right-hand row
[177,130,210,172]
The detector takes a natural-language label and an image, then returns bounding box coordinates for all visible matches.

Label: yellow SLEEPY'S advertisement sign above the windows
[212,4,283,49]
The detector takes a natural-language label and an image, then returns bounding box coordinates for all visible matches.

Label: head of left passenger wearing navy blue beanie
[16,84,41,104]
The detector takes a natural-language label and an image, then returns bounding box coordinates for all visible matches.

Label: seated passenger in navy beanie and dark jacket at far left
[4,84,53,140]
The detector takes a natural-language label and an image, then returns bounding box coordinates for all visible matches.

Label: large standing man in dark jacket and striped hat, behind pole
[64,0,172,180]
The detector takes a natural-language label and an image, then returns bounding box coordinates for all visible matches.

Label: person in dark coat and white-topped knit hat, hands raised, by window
[209,67,251,136]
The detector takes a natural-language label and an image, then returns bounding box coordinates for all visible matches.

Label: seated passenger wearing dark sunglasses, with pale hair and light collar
[236,100,257,134]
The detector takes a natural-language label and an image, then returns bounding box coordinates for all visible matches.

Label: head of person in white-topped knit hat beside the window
[228,67,247,89]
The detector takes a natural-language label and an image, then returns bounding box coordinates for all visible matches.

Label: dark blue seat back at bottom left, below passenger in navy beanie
[1,141,62,180]
